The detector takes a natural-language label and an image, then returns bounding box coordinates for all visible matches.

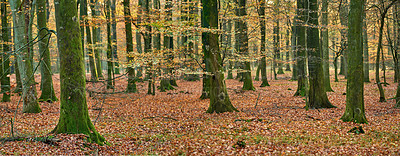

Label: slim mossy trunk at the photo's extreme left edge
[1,0,11,102]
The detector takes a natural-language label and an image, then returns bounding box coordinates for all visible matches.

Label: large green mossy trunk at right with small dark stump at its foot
[341,0,367,123]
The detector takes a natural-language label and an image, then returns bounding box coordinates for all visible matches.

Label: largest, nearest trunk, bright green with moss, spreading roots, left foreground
[52,0,105,144]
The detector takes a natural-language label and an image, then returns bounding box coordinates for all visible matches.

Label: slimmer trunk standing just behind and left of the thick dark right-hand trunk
[294,0,306,96]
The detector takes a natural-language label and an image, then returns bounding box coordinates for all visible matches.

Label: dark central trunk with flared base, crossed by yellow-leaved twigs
[201,0,238,113]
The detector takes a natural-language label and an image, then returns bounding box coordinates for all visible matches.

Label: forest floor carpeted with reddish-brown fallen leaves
[0,70,400,155]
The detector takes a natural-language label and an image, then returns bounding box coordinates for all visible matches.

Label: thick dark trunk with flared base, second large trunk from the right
[305,0,335,109]
